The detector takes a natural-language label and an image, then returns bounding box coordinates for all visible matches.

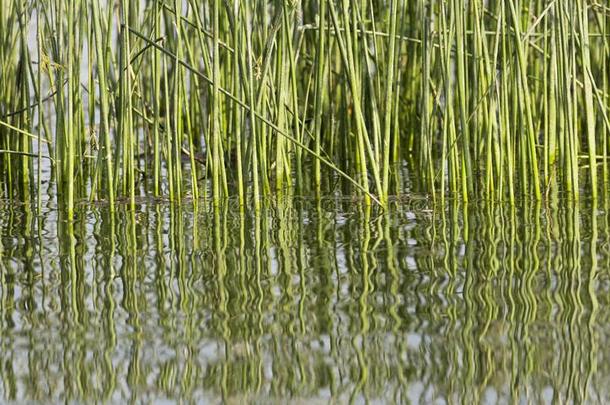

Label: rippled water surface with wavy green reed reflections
[0,198,610,403]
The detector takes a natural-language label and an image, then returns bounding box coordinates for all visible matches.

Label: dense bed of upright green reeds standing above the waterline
[0,0,610,215]
